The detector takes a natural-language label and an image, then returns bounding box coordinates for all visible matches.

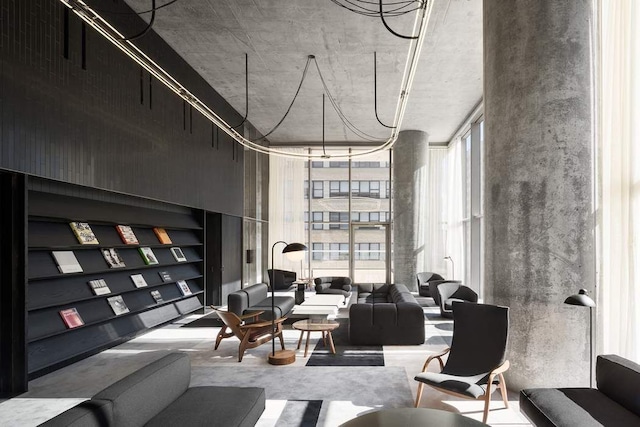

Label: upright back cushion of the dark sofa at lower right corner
[596,354,640,418]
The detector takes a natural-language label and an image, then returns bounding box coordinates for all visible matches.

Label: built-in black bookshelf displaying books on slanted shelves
[27,192,204,378]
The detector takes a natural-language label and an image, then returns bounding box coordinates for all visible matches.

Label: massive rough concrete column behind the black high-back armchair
[483,0,595,390]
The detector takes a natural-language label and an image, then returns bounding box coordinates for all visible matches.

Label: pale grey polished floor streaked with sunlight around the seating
[0,294,530,427]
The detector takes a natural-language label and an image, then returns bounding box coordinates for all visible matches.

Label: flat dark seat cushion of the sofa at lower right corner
[520,388,640,427]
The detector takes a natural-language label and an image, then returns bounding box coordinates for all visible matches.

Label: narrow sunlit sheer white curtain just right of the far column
[445,138,466,280]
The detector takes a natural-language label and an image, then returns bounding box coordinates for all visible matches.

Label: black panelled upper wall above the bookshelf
[0,0,249,216]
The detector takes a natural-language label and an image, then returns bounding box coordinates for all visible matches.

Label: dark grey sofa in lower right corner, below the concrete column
[520,355,640,427]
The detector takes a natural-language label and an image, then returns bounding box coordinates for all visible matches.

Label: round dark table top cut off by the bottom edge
[340,408,487,427]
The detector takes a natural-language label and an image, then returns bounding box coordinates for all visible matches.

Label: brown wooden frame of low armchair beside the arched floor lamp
[211,306,287,362]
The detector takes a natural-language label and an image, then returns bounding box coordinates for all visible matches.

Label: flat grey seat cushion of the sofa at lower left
[146,386,265,427]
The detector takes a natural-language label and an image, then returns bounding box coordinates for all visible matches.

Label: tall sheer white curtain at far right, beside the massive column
[598,0,640,362]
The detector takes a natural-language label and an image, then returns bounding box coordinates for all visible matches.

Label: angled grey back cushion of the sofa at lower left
[93,353,191,427]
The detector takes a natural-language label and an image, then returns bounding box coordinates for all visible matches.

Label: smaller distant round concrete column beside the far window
[392,130,429,290]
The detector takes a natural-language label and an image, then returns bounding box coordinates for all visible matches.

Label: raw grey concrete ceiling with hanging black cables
[126,0,482,144]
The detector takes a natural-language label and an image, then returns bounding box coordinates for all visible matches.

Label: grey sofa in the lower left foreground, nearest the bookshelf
[41,353,265,427]
